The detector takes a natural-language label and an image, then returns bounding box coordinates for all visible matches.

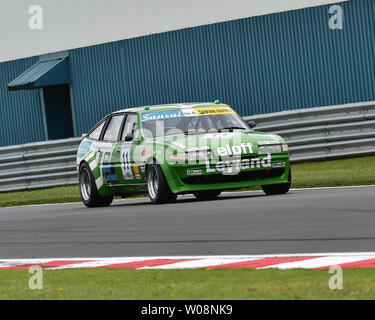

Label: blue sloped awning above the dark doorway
[7,58,70,90]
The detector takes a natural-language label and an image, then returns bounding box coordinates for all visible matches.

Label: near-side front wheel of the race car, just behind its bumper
[147,162,177,204]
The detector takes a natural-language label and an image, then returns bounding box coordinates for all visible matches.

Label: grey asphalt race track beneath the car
[0,186,375,259]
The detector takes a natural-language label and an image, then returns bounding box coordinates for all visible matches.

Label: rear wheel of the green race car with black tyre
[79,162,113,208]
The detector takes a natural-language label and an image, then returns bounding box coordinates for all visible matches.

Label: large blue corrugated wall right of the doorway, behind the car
[69,0,375,133]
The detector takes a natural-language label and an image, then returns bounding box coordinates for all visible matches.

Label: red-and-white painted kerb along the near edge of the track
[0,252,375,270]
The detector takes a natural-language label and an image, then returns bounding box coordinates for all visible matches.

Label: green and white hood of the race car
[156,130,285,156]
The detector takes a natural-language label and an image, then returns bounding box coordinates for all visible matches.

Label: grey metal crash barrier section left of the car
[0,138,81,192]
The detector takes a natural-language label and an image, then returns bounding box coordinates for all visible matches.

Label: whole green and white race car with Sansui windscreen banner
[77,101,291,207]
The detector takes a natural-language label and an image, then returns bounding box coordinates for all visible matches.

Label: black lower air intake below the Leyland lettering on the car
[182,168,285,184]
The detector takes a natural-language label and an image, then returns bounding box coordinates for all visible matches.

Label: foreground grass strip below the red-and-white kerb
[0,269,375,300]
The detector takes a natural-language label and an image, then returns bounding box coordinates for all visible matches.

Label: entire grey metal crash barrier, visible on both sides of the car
[0,102,375,192]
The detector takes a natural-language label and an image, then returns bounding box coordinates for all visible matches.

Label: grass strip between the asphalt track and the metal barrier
[0,156,375,207]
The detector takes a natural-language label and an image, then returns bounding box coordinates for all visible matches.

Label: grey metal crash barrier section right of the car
[245,102,375,162]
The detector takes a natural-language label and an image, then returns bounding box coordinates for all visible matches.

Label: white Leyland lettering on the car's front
[206,154,272,173]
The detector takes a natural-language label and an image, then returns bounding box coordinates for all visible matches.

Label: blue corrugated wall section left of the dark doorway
[0,58,44,146]
